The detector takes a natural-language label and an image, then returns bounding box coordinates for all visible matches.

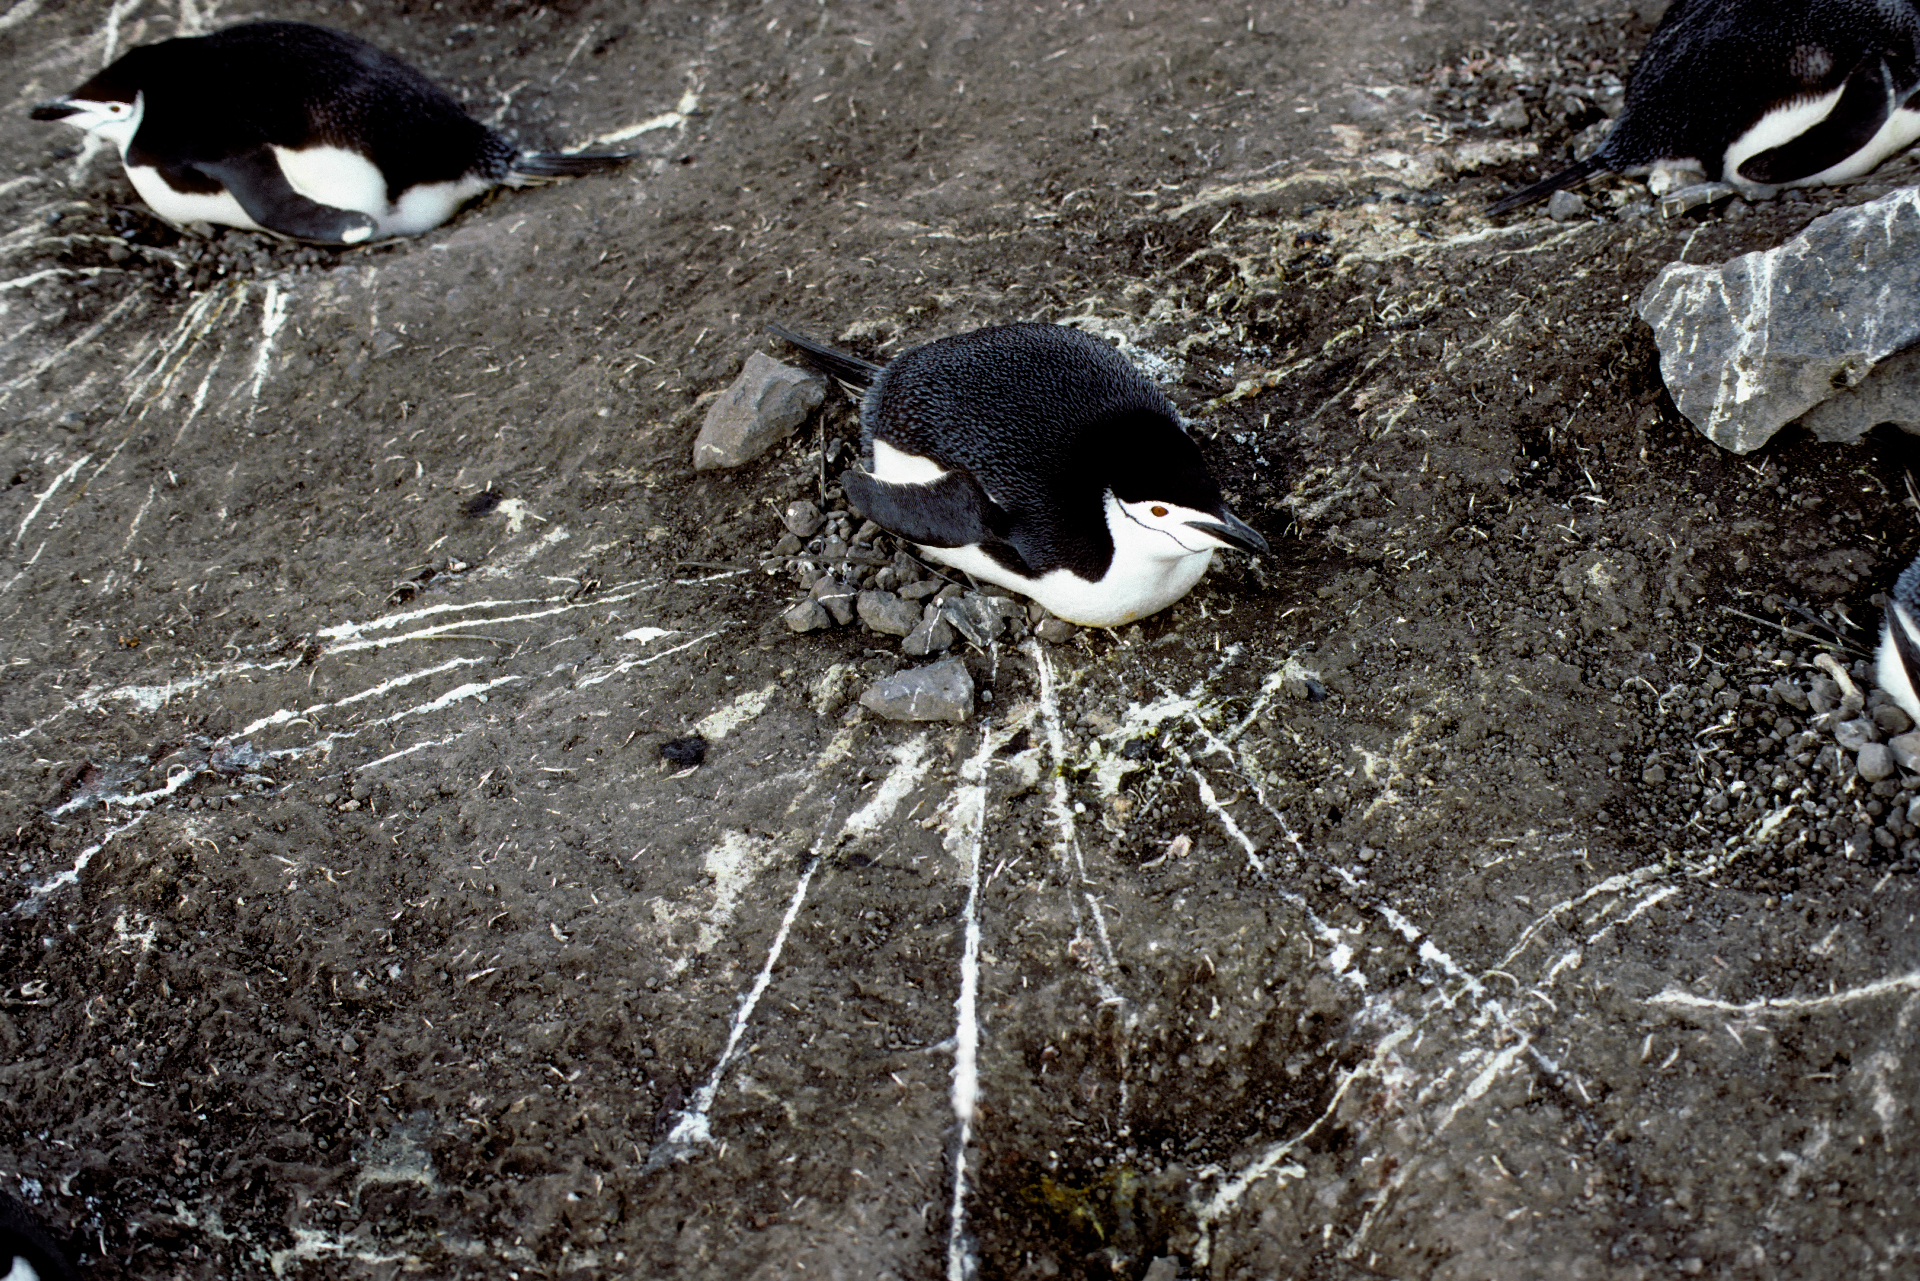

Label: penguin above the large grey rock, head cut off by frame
[1488,0,1920,213]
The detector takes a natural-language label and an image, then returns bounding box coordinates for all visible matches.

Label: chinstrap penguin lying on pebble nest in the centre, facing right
[770,325,1267,626]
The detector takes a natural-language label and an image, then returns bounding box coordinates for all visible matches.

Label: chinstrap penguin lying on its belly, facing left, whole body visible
[33,23,632,244]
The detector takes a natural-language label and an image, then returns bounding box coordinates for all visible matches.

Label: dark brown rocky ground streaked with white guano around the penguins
[0,0,1920,1281]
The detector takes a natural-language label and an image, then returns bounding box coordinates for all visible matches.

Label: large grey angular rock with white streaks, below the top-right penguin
[1638,188,1920,453]
